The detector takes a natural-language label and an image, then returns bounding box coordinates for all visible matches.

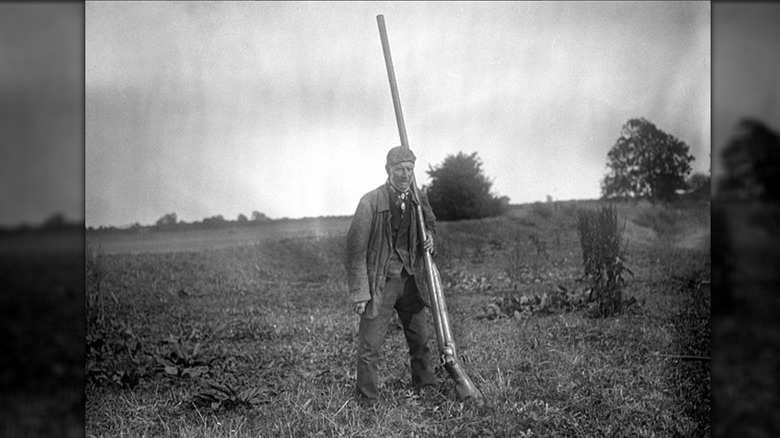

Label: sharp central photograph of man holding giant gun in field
[84,2,713,437]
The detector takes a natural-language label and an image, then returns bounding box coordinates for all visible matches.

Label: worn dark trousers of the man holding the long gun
[357,271,436,399]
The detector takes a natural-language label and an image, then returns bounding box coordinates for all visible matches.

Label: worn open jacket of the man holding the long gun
[344,184,436,319]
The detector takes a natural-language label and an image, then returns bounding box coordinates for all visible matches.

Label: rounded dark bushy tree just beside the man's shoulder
[426,152,508,221]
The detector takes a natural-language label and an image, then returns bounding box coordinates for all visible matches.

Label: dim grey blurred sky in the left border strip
[0,2,84,226]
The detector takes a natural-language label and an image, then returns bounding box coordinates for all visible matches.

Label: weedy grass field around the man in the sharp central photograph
[86,202,710,437]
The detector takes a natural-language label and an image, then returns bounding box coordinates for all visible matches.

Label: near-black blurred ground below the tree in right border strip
[712,201,780,437]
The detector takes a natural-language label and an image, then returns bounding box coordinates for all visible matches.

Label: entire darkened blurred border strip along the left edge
[0,2,85,438]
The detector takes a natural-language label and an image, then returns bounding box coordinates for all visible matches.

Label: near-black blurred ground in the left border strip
[0,229,85,437]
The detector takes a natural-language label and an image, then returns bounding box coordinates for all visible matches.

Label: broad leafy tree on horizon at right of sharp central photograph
[601,118,694,201]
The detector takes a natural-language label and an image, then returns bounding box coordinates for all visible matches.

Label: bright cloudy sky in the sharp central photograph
[85,2,711,226]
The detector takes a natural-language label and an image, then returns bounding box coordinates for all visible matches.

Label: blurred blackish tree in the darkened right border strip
[717,119,780,201]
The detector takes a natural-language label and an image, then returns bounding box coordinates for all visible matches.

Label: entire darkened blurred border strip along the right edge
[711,2,780,437]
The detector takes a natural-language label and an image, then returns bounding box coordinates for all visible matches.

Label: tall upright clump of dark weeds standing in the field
[577,205,634,317]
